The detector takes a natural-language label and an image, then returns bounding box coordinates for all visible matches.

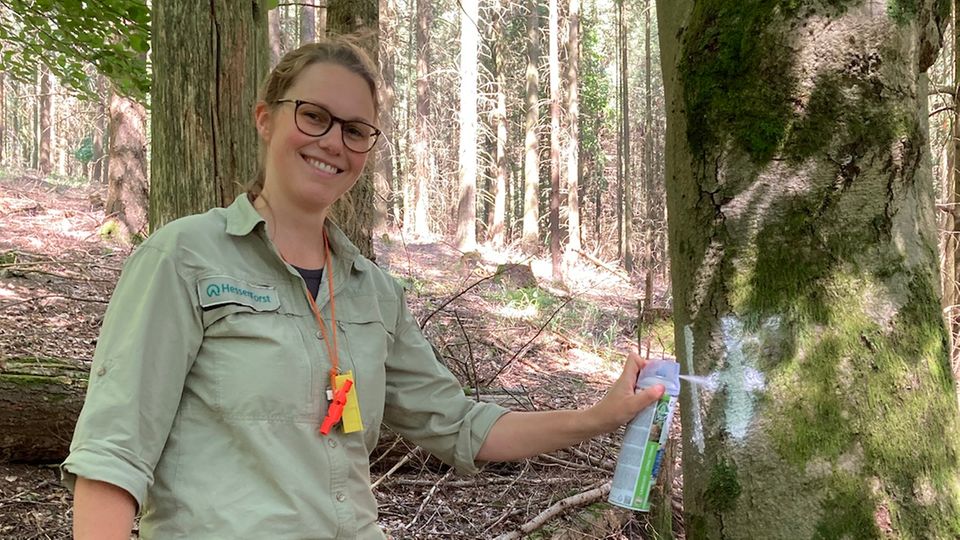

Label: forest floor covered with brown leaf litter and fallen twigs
[0,175,684,540]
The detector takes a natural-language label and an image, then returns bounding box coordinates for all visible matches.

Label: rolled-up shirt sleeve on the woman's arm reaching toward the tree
[384,292,508,474]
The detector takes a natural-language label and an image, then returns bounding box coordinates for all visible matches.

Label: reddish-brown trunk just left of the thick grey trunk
[104,93,148,242]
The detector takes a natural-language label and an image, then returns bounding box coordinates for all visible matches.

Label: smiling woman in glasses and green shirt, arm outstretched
[62,41,662,540]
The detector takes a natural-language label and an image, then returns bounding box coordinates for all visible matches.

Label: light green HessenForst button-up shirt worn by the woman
[62,196,506,540]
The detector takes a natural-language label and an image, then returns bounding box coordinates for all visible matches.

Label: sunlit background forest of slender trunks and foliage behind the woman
[0,0,960,540]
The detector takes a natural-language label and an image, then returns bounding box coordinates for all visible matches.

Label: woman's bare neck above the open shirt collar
[253,190,327,269]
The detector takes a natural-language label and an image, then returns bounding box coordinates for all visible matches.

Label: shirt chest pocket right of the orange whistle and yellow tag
[337,295,399,442]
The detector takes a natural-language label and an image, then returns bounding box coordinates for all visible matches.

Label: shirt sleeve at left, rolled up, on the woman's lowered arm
[61,242,203,505]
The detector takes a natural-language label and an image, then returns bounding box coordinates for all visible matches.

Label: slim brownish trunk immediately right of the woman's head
[374,0,398,230]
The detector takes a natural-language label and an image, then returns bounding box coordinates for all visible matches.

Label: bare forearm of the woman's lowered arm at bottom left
[73,477,137,540]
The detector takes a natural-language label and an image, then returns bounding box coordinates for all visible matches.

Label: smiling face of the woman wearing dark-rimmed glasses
[256,63,376,212]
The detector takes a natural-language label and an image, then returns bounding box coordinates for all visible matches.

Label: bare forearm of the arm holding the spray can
[476,410,615,461]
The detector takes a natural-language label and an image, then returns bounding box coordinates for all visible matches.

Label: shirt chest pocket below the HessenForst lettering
[199,304,318,423]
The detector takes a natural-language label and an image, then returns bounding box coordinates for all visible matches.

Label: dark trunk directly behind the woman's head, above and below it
[327,0,380,260]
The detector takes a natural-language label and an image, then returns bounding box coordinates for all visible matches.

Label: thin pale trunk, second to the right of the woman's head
[412,0,433,237]
